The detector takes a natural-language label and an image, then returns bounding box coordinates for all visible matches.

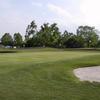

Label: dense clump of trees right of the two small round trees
[23,21,99,48]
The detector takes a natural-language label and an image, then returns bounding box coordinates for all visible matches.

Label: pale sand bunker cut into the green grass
[74,66,100,82]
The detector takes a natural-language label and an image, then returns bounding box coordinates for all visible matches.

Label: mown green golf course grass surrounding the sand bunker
[0,48,100,100]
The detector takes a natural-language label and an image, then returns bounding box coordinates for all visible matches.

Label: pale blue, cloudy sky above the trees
[0,0,100,36]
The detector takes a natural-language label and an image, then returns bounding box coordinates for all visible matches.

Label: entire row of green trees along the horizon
[1,21,100,48]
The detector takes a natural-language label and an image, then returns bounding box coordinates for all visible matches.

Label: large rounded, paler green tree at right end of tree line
[77,26,99,47]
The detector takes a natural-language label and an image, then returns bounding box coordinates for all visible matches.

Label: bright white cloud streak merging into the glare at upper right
[47,0,100,29]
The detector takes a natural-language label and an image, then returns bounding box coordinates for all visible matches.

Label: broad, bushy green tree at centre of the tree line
[37,23,60,47]
